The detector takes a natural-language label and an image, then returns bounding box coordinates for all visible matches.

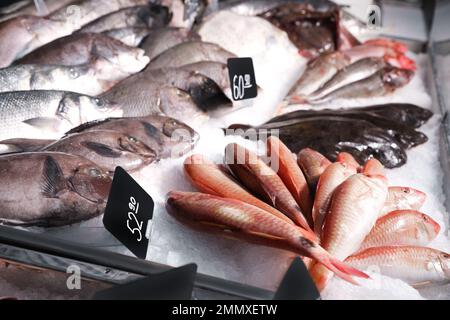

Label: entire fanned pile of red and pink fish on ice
[166,136,450,289]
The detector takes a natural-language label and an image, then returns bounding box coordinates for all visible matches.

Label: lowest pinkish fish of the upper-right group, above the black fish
[298,67,414,104]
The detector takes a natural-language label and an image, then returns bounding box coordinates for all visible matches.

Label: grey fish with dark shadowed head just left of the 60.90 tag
[103,68,232,112]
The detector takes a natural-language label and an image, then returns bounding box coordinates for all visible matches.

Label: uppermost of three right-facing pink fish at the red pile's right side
[380,187,427,217]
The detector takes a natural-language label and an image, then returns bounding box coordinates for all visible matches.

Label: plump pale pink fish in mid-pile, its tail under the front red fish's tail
[311,170,388,290]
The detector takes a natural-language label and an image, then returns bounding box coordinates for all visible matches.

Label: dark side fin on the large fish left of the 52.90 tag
[41,156,66,198]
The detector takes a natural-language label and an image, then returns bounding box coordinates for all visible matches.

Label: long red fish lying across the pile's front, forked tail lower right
[166,191,367,283]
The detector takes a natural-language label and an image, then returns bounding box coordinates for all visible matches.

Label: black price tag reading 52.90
[103,167,155,259]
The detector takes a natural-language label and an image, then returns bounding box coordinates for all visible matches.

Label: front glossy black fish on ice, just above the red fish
[233,116,410,168]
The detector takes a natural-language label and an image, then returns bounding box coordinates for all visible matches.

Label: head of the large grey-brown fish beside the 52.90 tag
[69,161,112,203]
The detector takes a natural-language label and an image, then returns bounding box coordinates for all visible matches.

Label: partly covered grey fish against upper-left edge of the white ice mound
[141,27,201,60]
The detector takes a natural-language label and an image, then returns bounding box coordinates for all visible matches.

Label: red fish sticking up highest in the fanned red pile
[267,136,312,219]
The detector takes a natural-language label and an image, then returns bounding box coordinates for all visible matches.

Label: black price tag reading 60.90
[228,58,258,101]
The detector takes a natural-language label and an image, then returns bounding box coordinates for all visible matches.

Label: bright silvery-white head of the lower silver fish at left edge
[57,93,122,125]
